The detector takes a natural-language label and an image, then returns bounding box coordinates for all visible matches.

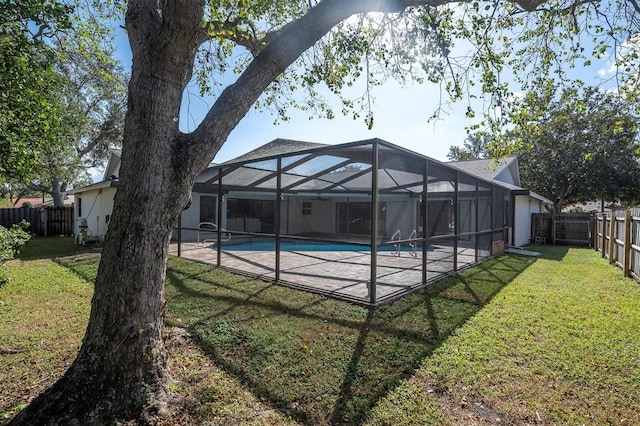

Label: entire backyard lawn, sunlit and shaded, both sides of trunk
[0,239,640,425]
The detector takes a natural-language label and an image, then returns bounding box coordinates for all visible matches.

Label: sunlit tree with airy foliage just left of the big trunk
[0,5,126,207]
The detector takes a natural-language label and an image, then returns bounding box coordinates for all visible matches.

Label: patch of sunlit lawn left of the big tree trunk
[0,240,93,420]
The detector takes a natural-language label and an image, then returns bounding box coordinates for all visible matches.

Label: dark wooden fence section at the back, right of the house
[531,213,595,247]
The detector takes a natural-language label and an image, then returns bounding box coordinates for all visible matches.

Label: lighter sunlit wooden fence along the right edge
[594,208,640,281]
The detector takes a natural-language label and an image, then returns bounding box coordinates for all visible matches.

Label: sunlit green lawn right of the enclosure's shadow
[368,247,640,425]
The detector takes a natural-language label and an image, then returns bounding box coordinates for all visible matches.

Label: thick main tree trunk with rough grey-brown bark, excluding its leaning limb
[12,2,203,425]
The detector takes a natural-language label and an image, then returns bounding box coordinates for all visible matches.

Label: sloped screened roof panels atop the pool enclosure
[197,139,522,194]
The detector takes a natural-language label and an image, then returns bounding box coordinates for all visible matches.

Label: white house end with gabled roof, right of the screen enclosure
[447,157,553,247]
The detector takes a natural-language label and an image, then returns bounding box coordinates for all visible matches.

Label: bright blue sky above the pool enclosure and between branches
[100,9,612,177]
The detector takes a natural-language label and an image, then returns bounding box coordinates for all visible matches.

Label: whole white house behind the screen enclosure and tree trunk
[69,139,549,246]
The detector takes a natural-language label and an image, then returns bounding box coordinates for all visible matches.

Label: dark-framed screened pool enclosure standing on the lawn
[176,139,513,306]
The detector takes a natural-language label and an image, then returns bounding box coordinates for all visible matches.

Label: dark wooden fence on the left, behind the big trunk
[0,207,74,237]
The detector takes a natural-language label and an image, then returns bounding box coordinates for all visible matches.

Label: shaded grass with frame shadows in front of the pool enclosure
[162,251,537,425]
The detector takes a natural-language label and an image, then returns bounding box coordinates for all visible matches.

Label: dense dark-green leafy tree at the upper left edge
[0,0,71,180]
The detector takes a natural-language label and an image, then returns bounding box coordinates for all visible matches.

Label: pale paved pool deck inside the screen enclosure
[169,242,475,304]
